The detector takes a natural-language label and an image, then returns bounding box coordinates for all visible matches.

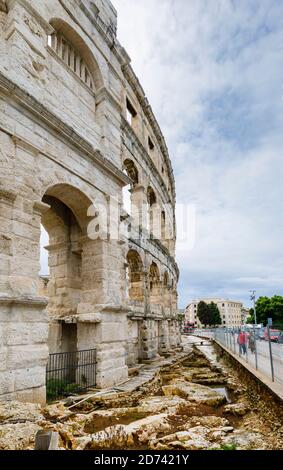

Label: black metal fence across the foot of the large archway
[46,349,96,401]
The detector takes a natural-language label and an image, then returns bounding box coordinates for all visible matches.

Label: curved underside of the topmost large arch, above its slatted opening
[50,18,103,91]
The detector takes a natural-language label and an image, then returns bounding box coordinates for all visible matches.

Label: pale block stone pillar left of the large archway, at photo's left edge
[0,191,48,403]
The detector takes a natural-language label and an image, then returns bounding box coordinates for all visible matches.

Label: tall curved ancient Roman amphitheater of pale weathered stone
[0,0,179,402]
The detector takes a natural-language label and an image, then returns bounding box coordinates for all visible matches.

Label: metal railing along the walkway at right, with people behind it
[194,328,283,385]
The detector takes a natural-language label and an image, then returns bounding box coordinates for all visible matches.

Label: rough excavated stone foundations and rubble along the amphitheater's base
[0,346,283,450]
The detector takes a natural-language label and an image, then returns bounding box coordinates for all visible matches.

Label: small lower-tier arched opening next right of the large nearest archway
[127,250,144,301]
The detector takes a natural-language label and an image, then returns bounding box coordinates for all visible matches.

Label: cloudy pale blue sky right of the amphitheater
[112,0,283,307]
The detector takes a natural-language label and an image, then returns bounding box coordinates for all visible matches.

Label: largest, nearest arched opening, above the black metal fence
[38,184,91,352]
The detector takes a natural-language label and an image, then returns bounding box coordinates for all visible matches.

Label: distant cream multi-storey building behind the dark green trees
[185,298,245,328]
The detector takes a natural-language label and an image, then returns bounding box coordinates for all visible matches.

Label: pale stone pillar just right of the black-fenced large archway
[75,238,128,388]
